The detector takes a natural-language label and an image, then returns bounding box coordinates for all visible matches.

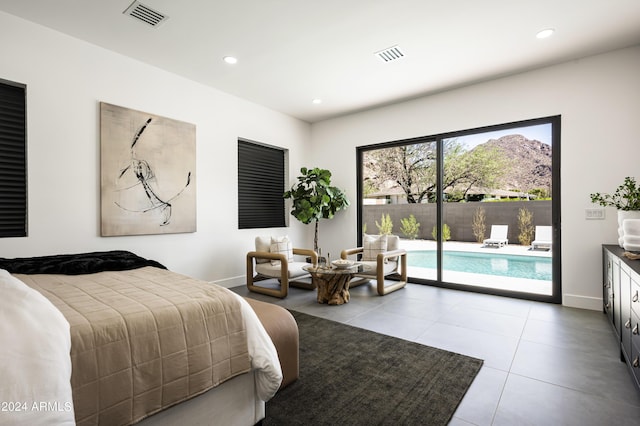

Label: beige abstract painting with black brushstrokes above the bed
[100,102,196,237]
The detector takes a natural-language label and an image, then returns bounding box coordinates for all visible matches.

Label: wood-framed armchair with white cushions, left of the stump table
[247,237,318,299]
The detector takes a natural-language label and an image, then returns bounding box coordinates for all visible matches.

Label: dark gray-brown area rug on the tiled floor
[262,311,483,425]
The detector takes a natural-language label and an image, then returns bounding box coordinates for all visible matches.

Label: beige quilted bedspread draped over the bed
[15,267,250,425]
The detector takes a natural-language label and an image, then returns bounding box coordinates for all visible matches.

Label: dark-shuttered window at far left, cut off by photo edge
[0,80,27,237]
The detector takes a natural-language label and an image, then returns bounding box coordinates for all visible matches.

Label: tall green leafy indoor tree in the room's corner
[284,167,349,255]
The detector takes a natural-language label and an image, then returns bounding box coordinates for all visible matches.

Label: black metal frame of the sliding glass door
[356,115,562,304]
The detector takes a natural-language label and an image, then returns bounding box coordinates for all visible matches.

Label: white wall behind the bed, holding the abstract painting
[0,12,313,286]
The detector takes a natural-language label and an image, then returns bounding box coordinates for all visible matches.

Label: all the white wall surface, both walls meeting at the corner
[0,12,640,309]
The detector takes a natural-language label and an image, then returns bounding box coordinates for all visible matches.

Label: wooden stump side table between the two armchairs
[302,264,370,305]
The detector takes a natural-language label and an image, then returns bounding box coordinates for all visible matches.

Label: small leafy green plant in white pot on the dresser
[591,176,640,251]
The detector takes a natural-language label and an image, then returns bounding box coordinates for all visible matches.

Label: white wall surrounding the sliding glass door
[311,46,640,309]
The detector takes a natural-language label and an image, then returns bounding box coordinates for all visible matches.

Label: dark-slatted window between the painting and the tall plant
[238,139,286,229]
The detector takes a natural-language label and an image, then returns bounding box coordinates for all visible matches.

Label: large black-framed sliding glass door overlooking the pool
[358,117,560,303]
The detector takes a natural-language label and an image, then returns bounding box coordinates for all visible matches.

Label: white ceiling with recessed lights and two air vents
[0,0,640,122]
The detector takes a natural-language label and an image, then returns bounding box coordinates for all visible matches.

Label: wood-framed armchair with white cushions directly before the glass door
[340,235,407,296]
